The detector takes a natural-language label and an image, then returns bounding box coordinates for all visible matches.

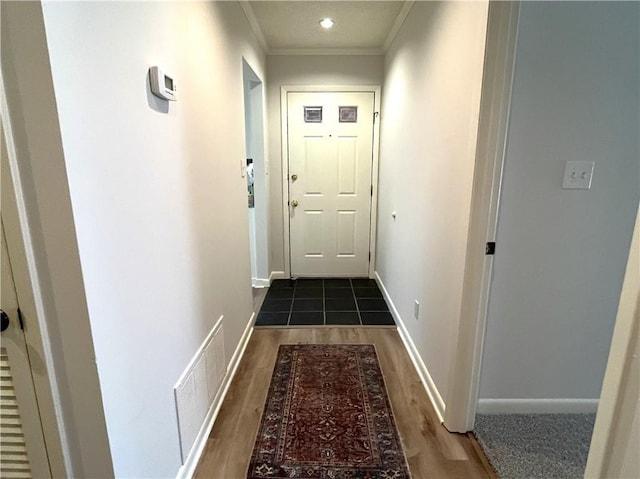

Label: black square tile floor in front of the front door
[256,278,395,327]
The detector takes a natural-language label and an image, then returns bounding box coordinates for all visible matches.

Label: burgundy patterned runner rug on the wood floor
[247,344,410,479]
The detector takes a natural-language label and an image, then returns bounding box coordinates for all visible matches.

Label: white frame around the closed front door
[280,85,381,278]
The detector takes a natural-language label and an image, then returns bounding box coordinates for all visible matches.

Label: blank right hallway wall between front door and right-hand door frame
[376,2,488,408]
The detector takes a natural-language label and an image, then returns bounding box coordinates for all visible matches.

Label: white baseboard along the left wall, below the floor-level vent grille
[176,313,255,479]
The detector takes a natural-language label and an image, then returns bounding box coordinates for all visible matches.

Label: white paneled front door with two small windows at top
[287,92,374,277]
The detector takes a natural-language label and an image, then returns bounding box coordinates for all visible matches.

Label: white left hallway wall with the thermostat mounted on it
[44,2,265,477]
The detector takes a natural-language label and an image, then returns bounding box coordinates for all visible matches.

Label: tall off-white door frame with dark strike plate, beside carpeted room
[443,2,520,432]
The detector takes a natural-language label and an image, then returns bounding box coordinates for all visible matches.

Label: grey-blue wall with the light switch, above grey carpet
[480,2,640,399]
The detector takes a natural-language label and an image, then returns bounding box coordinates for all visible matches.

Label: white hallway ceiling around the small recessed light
[241,0,414,55]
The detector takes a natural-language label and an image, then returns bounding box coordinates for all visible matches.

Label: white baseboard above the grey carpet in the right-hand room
[477,399,598,414]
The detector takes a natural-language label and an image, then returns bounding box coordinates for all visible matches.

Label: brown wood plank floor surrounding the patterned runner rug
[194,328,497,479]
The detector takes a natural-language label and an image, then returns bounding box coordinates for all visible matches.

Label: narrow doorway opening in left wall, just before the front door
[242,59,269,297]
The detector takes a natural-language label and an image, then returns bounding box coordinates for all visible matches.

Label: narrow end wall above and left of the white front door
[267,55,384,271]
